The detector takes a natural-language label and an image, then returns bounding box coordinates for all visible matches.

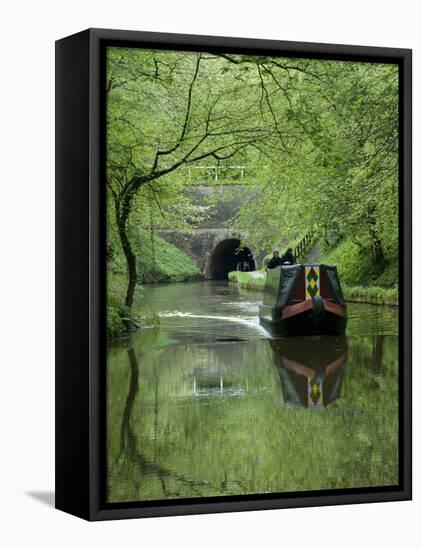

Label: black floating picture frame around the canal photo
[56,29,412,520]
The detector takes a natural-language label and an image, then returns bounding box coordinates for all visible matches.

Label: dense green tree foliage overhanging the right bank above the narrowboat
[231,61,398,282]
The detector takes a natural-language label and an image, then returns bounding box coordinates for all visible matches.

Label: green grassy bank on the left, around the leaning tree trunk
[107,232,201,340]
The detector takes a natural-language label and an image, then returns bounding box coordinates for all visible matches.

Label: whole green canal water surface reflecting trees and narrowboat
[107,281,398,502]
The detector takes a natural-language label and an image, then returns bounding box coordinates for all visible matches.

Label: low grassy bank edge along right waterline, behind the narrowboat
[229,271,398,306]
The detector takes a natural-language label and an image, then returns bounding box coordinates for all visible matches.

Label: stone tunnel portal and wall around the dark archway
[158,185,257,279]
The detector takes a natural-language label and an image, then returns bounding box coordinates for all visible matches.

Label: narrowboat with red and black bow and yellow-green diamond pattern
[259,263,347,336]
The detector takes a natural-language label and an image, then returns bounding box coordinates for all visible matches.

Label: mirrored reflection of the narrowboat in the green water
[270,336,347,408]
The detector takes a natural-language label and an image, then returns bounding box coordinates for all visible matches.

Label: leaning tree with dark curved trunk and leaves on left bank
[107,48,288,307]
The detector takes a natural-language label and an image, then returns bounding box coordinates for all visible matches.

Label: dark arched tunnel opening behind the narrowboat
[208,239,255,279]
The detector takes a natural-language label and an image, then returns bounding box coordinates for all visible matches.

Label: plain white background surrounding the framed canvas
[0,0,422,550]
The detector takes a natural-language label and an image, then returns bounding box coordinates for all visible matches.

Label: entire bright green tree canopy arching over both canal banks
[107,47,398,308]
